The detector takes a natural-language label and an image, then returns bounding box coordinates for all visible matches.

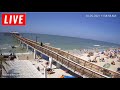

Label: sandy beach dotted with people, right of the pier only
[68,49,120,72]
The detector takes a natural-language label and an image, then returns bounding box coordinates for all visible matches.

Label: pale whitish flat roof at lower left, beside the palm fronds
[3,60,43,78]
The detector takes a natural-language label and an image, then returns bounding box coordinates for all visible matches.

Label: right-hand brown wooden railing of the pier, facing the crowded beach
[44,45,120,78]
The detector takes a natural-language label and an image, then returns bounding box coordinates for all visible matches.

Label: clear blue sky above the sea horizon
[0,12,120,44]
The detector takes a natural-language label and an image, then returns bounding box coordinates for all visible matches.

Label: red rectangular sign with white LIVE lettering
[2,14,26,26]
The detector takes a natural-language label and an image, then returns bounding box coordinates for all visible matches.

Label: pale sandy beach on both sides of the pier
[17,49,120,78]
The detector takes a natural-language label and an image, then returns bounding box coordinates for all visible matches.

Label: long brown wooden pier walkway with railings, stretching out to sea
[14,35,120,78]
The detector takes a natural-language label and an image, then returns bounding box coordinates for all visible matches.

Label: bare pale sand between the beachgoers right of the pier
[69,50,120,72]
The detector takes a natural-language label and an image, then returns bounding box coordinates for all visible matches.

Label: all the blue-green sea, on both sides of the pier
[0,33,120,52]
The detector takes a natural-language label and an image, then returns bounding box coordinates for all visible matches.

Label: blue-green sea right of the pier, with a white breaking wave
[21,33,120,50]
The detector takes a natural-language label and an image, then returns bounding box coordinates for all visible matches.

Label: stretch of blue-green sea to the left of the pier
[0,33,26,54]
